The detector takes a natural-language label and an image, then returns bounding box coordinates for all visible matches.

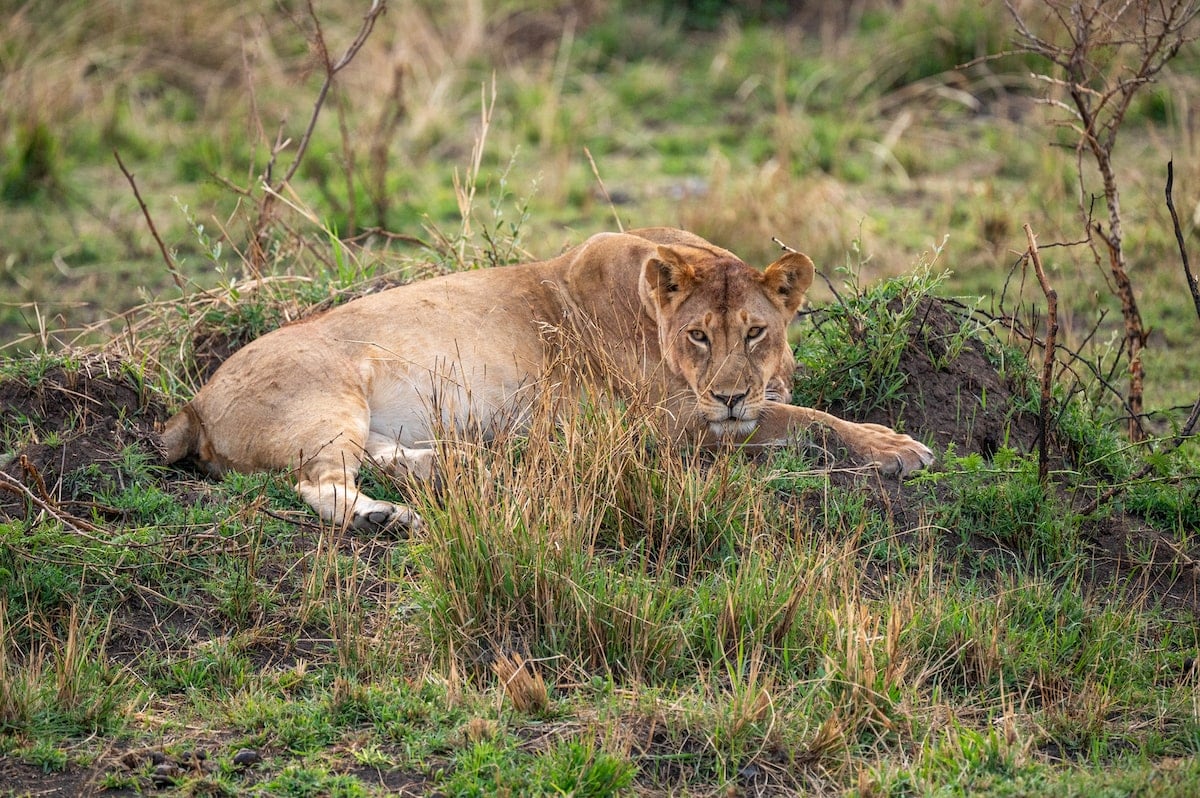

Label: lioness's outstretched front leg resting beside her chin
[749,402,934,475]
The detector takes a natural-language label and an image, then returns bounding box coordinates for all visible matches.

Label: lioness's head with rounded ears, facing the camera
[640,246,814,436]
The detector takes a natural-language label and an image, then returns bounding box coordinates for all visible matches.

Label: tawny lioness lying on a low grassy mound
[163,228,934,528]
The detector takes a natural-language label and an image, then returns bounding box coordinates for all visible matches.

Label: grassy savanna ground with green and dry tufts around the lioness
[0,0,1200,796]
